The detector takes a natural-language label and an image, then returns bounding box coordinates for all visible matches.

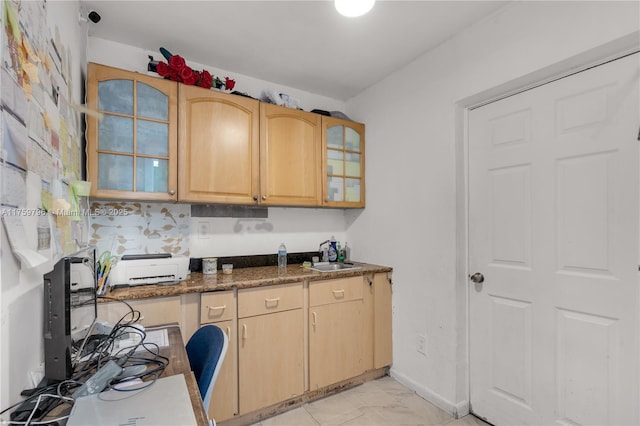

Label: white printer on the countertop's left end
[109,253,189,287]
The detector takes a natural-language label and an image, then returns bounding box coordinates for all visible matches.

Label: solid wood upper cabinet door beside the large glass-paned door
[178,84,260,204]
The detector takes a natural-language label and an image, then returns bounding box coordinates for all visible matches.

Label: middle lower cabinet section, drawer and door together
[238,283,305,414]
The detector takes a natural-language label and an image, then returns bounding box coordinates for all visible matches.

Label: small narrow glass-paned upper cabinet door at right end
[323,117,365,207]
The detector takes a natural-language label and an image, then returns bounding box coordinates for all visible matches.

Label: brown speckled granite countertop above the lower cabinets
[100,262,392,302]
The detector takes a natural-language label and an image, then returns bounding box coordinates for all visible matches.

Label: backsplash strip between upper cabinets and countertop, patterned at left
[89,201,350,260]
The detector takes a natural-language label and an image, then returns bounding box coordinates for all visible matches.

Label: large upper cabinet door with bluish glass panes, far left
[87,63,178,201]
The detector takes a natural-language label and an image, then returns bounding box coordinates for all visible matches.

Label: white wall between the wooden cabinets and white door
[347,1,640,413]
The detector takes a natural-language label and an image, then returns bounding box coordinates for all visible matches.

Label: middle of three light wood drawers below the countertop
[238,283,303,318]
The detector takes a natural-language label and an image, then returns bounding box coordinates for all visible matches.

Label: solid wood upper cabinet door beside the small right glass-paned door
[260,103,322,206]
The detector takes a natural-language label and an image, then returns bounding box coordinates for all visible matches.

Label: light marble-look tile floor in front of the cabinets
[248,377,488,426]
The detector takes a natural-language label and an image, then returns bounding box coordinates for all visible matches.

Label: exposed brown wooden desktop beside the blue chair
[145,324,209,426]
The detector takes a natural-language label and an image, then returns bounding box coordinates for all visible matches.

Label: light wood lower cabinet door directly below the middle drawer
[238,309,304,414]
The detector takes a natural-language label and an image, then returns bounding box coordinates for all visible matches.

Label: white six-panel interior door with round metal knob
[469,54,640,425]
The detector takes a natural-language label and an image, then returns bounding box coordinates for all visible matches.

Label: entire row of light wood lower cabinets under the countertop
[98,272,392,422]
